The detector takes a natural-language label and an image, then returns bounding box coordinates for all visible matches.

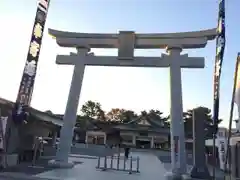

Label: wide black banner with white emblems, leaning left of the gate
[12,0,50,123]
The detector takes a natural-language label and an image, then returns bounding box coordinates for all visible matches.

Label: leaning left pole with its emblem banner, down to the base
[6,0,50,153]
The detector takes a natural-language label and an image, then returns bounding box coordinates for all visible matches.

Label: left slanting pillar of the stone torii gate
[49,48,89,168]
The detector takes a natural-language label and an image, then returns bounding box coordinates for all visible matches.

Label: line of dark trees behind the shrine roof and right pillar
[78,101,222,138]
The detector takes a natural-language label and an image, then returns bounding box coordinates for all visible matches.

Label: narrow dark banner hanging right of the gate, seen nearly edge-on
[213,0,225,134]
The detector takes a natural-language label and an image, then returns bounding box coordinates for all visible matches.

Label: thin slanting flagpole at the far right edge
[224,52,240,178]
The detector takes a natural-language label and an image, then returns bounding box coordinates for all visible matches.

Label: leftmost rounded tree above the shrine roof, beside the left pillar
[81,101,105,120]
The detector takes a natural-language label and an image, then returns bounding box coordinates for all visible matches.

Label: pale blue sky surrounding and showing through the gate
[0,0,240,126]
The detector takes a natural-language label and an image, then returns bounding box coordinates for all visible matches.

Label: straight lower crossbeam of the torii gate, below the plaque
[56,53,205,68]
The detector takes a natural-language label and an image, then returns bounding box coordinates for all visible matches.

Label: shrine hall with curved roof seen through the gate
[75,117,170,148]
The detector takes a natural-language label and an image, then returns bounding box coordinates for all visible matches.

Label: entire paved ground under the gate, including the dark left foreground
[0,146,227,180]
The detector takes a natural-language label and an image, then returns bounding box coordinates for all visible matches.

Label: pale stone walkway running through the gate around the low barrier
[33,152,166,180]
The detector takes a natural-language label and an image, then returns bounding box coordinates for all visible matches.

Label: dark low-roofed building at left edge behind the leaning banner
[0,98,63,154]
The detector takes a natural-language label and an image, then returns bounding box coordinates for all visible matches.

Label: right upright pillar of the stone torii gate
[167,47,187,174]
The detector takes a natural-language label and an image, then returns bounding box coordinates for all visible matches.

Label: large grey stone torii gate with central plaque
[49,29,216,174]
